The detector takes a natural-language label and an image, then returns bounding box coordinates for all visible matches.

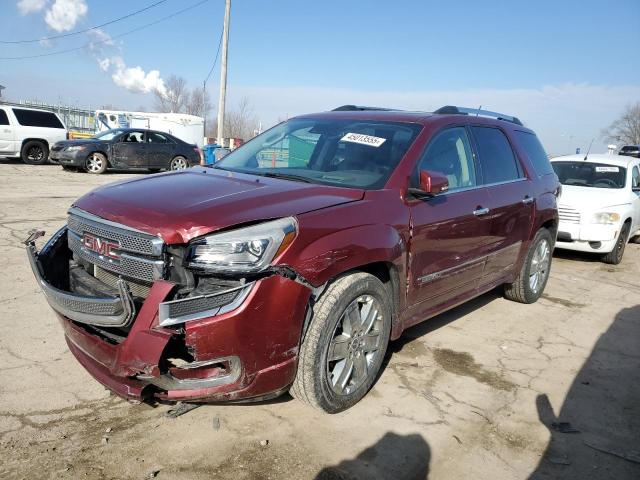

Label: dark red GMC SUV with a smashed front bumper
[26,105,560,412]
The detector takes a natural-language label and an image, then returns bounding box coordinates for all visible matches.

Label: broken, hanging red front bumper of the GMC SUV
[25,228,310,402]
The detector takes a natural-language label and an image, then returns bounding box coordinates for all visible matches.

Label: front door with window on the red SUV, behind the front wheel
[409,127,491,312]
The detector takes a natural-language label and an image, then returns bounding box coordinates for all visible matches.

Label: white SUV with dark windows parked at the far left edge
[0,104,68,165]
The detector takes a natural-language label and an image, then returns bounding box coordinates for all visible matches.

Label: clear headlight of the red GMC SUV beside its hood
[187,217,298,273]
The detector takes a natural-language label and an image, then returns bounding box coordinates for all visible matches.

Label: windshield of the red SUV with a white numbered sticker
[214,119,422,189]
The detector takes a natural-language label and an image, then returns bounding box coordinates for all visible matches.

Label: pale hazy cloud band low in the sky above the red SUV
[228,83,640,154]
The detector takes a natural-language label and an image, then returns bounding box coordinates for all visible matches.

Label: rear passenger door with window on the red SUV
[470,125,535,287]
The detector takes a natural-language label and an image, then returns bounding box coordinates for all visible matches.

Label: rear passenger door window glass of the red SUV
[471,127,521,184]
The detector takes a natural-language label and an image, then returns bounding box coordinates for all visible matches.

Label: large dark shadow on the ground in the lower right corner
[529,305,640,480]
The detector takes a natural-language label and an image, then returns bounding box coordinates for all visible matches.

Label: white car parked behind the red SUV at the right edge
[551,154,640,264]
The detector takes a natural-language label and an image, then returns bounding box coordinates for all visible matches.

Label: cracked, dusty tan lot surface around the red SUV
[0,159,640,479]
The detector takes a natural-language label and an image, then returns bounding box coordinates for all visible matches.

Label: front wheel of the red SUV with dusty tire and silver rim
[289,272,391,413]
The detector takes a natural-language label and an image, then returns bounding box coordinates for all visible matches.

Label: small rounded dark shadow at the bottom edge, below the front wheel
[315,432,431,480]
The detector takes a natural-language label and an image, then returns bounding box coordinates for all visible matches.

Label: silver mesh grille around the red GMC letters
[67,208,164,290]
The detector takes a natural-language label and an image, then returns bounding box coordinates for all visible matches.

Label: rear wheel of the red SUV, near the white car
[504,228,553,303]
